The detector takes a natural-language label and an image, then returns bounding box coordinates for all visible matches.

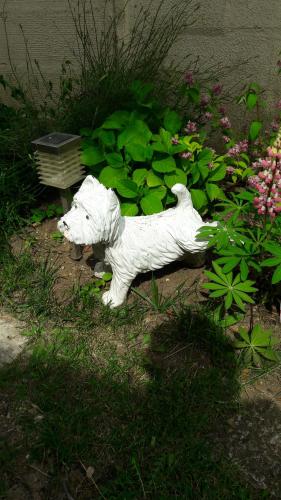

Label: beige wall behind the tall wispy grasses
[0,0,281,116]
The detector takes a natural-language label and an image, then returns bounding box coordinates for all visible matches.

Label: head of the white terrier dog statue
[58,175,121,245]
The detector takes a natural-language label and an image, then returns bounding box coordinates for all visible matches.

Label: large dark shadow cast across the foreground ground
[0,309,281,500]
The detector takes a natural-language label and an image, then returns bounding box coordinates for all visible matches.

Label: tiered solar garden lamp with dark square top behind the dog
[32,132,84,260]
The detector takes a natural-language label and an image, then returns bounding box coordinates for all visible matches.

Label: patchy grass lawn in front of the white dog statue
[0,246,252,500]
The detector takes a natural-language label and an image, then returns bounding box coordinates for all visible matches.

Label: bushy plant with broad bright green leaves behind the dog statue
[81,104,226,215]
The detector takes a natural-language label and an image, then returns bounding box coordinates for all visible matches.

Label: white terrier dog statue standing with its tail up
[58,175,213,308]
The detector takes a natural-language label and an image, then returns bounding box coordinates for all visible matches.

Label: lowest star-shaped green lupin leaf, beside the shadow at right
[233,325,280,367]
